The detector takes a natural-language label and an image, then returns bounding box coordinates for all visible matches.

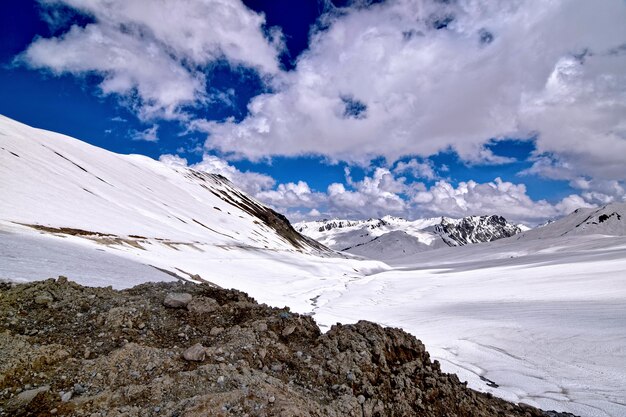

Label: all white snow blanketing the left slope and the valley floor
[0,117,626,417]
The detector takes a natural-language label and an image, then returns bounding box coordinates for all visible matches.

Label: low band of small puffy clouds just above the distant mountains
[160,154,600,225]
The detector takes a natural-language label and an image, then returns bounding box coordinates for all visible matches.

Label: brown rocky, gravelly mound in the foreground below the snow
[0,277,576,417]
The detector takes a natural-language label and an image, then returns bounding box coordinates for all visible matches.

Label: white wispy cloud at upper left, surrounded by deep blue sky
[20,0,281,119]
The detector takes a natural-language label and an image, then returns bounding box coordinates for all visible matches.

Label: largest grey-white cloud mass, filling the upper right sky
[205,0,626,178]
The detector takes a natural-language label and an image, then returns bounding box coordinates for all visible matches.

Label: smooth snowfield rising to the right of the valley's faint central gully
[315,203,626,417]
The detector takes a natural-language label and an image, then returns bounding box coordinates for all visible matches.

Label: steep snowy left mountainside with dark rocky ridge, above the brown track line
[0,112,324,251]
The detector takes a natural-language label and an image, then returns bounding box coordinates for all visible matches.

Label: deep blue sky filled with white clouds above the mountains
[0,0,626,225]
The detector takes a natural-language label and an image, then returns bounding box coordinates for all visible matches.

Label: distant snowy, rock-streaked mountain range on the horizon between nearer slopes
[294,216,527,260]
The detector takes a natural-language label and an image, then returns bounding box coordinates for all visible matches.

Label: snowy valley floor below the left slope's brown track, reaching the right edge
[0,224,626,417]
